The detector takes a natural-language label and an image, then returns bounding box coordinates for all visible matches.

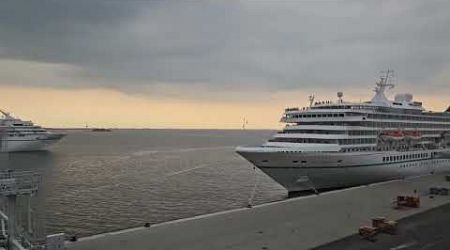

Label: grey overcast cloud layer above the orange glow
[0,0,450,128]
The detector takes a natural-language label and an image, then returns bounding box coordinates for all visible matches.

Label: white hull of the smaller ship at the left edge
[0,134,64,152]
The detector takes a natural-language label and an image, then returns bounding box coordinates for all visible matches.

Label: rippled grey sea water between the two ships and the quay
[0,130,286,236]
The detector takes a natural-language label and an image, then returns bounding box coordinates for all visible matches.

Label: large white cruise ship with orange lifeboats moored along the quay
[236,71,450,194]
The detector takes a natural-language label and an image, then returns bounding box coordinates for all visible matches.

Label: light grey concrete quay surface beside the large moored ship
[66,174,450,250]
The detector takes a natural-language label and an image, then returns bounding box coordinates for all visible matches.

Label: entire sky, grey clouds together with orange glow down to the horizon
[0,0,450,129]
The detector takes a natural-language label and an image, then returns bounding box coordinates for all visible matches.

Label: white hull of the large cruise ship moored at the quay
[237,148,450,192]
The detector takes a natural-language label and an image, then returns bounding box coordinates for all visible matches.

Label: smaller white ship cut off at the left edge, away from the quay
[0,110,64,152]
